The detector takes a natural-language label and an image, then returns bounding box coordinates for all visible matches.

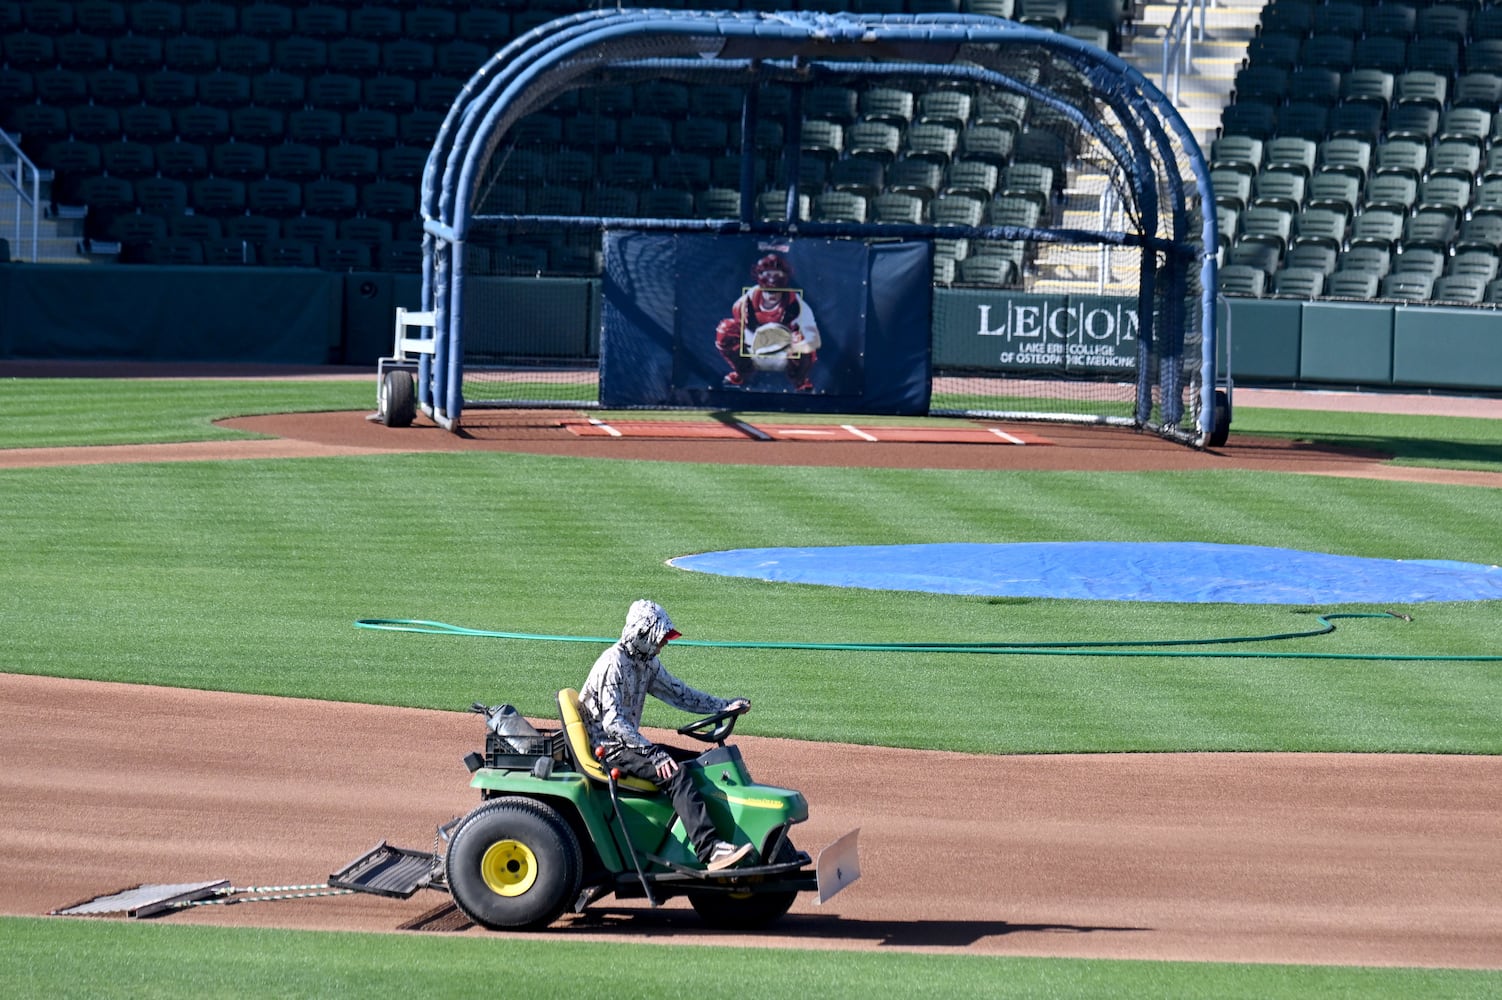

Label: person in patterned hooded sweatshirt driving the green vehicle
[578,601,751,871]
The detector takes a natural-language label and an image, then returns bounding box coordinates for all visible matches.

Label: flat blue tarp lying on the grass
[668,542,1502,604]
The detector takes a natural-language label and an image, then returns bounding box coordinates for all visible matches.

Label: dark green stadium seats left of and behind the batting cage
[0,0,1135,276]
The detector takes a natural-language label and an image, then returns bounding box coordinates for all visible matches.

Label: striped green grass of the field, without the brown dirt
[0,380,1502,997]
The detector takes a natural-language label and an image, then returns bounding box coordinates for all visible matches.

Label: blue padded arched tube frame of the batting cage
[418,9,1218,441]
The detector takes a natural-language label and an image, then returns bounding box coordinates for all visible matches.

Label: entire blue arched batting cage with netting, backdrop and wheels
[380,11,1230,444]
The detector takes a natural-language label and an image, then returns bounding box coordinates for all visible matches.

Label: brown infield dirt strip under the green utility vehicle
[0,669,1502,968]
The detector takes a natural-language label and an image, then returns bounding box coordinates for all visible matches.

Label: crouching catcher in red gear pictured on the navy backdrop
[715,254,819,392]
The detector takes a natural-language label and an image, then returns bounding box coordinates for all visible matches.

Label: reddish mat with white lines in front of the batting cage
[562,417,1053,444]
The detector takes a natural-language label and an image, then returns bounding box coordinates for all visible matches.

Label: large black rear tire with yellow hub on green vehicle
[448,799,584,931]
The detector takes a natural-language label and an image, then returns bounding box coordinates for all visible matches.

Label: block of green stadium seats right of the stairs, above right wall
[1209,0,1502,305]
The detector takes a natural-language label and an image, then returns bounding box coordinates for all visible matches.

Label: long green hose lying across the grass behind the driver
[354,611,1502,662]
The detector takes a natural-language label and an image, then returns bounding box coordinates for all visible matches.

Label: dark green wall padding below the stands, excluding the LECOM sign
[0,264,1502,392]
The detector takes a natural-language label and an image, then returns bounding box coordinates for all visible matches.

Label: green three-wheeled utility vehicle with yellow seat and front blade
[329,689,861,929]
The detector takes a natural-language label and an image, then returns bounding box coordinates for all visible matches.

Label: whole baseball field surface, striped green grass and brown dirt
[0,363,1502,997]
